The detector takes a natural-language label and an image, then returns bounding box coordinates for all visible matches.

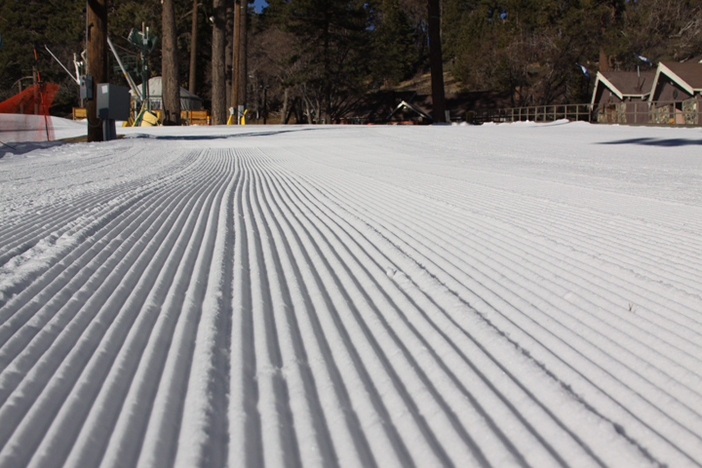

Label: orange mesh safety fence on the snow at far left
[0,83,59,142]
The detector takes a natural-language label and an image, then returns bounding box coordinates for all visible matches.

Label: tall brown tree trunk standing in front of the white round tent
[161,0,180,125]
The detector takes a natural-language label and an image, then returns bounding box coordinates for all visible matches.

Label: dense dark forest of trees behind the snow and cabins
[0,0,702,122]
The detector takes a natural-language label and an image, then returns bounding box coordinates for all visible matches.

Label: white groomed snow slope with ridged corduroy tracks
[0,122,702,468]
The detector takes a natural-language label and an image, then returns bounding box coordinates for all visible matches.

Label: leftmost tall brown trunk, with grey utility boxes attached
[86,0,109,141]
